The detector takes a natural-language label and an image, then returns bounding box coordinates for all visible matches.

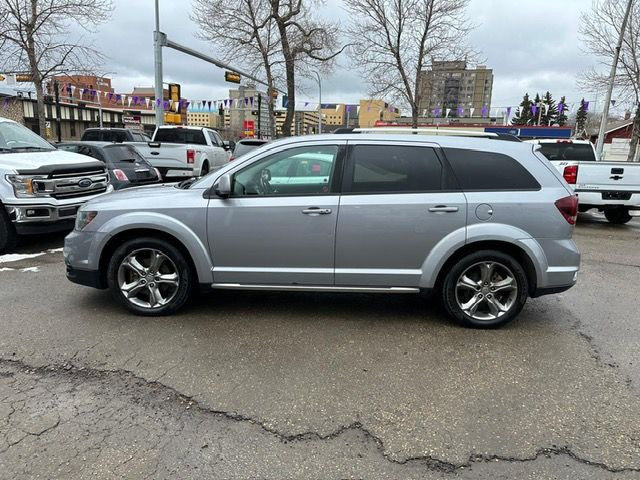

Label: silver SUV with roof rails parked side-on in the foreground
[64,133,580,327]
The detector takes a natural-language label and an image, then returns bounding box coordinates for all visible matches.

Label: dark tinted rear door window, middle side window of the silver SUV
[345,145,442,193]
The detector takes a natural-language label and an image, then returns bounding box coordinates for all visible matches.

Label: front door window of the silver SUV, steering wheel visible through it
[233,145,338,196]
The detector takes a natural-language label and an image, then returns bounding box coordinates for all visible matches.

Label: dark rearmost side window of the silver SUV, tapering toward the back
[444,148,540,190]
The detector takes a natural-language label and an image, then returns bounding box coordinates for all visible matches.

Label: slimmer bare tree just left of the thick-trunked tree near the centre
[191,0,282,137]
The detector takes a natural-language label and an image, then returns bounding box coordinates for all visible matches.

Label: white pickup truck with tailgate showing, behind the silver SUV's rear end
[527,139,640,224]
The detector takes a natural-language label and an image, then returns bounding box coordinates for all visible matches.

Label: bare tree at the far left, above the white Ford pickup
[0,0,112,134]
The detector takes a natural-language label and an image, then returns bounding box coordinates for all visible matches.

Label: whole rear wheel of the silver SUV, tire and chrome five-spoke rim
[442,250,528,328]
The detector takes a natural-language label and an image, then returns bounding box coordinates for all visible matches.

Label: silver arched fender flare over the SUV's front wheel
[96,212,213,284]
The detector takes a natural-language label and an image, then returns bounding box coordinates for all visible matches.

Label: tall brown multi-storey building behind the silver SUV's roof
[418,61,493,117]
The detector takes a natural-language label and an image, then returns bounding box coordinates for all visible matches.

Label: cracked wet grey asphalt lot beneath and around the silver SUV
[0,215,640,479]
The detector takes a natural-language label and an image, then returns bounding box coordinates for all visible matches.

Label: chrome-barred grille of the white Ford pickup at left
[34,167,109,200]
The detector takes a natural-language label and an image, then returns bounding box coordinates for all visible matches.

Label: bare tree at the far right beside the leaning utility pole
[579,0,640,161]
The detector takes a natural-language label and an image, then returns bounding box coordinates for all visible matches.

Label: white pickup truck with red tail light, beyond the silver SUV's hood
[130,126,229,178]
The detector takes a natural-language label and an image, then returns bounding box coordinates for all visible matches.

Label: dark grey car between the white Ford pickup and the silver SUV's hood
[58,142,162,190]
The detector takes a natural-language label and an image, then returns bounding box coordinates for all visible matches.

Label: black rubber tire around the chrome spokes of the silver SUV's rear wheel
[442,250,529,328]
